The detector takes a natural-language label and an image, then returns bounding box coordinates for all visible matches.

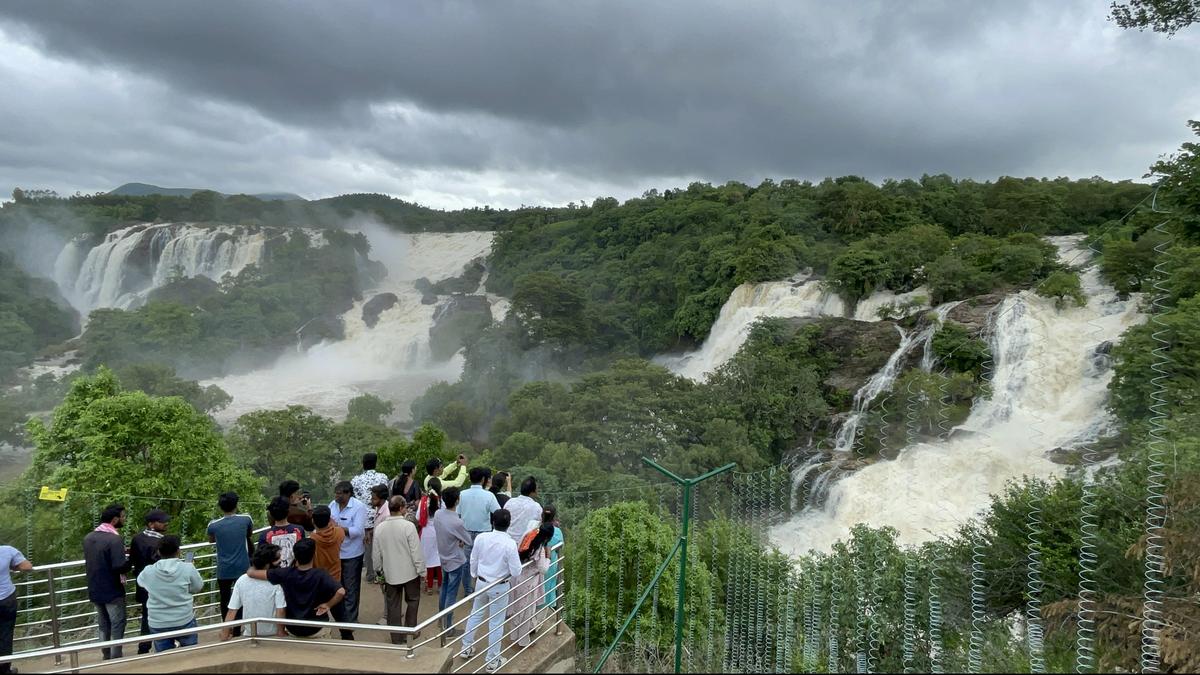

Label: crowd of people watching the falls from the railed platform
[0,453,563,673]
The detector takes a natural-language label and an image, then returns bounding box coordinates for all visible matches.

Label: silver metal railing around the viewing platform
[0,535,566,673]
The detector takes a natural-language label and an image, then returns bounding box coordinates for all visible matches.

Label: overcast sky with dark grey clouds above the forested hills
[0,0,1200,208]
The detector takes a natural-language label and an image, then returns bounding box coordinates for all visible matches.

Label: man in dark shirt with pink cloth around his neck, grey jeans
[83,504,131,661]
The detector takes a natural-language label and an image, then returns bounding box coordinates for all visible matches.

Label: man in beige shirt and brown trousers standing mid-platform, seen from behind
[372,495,425,645]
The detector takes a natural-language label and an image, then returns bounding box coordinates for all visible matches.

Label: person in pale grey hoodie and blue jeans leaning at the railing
[138,534,204,652]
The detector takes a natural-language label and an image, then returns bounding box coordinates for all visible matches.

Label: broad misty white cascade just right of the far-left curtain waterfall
[204,229,503,424]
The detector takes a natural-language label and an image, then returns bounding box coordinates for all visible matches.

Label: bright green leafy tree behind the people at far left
[23,368,260,552]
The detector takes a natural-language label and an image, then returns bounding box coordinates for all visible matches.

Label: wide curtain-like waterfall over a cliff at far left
[54,222,276,316]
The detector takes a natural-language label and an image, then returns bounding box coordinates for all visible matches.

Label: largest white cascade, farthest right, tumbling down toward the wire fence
[773,235,1145,554]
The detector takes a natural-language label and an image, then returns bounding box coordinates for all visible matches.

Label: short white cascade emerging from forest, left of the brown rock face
[654,275,846,381]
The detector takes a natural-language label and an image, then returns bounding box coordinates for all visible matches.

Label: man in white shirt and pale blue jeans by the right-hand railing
[458,509,521,673]
